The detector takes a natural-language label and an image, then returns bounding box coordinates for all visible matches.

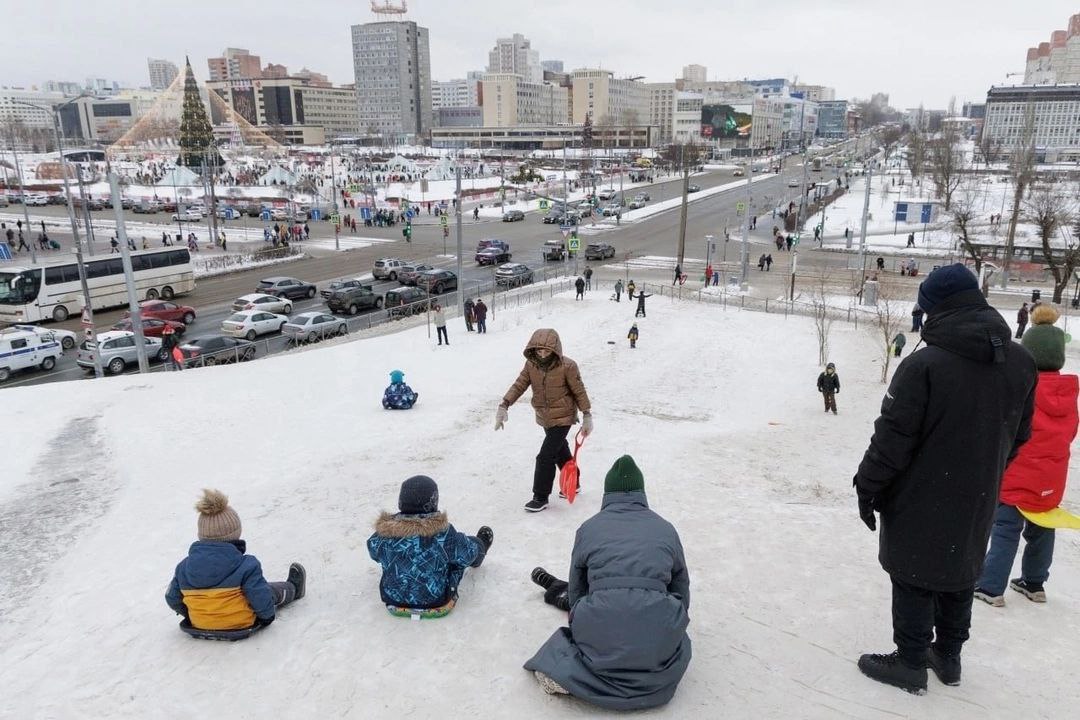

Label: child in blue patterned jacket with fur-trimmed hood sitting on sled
[367,475,495,617]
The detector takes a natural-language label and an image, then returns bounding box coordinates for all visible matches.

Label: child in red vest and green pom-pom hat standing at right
[975,304,1080,608]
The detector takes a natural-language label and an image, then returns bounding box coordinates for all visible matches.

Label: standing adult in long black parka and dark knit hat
[853,263,1036,694]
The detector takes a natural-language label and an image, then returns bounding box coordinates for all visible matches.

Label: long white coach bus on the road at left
[0,248,195,323]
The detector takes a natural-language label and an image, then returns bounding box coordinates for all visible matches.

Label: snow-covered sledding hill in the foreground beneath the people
[0,289,1080,720]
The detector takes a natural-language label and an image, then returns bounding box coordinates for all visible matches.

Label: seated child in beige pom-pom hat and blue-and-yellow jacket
[165,490,307,633]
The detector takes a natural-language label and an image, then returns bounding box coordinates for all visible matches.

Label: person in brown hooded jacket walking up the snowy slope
[495,328,593,513]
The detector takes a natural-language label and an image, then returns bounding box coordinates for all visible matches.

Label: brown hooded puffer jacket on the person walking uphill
[502,328,592,427]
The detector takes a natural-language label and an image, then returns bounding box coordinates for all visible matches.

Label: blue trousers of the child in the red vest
[977,503,1054,596]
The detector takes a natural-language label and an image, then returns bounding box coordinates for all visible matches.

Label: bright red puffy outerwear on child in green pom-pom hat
[1001,370,1078,513]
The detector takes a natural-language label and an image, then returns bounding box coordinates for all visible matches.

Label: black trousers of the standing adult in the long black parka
[892,576,975,667]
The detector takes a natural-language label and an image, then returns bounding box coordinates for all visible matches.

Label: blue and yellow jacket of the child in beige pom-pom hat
[165,540,275,630]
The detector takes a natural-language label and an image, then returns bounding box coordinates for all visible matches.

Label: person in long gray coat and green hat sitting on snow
[525,456,690,710]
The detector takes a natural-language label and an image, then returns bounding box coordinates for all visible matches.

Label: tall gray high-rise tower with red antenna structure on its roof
[352,21,432,138]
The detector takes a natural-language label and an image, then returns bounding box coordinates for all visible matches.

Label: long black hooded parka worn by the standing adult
[855,289,1036,592]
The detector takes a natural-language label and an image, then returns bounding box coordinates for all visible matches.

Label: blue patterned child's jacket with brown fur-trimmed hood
[367,513,487,609]
